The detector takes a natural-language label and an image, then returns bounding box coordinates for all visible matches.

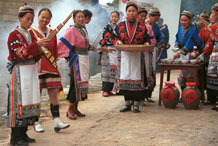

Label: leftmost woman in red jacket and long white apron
[7,5,49,146]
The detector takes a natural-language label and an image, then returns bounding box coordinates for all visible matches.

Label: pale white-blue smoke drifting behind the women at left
[0,0,109,111]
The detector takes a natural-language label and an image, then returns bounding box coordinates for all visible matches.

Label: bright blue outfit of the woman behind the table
[175,25,203,89]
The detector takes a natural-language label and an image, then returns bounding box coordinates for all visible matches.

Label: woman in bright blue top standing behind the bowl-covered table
[174,10,203,90]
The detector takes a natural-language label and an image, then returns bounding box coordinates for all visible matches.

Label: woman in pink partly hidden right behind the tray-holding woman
[137,7,157,106]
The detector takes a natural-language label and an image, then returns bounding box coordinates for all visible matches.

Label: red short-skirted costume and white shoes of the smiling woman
[30,27,69,132]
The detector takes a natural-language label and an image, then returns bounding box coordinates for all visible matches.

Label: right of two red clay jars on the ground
[182,82,201,109]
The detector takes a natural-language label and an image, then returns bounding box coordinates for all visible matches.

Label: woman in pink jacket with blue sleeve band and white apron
[58,10,90,120]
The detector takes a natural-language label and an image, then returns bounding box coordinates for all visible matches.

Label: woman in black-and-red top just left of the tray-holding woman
[99,11,119,97]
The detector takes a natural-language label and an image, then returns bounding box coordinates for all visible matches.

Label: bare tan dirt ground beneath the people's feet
[0,72,218,146]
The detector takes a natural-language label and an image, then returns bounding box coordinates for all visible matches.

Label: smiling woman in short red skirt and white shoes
[31,8,70,132]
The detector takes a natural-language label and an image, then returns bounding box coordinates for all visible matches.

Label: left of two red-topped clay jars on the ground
[161,81,180,109]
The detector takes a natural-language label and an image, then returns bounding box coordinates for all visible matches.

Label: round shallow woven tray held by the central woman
[115,44,154,52]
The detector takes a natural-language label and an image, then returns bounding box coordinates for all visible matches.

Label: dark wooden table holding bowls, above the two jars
[159,63,205,106]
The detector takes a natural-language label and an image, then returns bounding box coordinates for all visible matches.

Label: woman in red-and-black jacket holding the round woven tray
[112,2,149,112]
